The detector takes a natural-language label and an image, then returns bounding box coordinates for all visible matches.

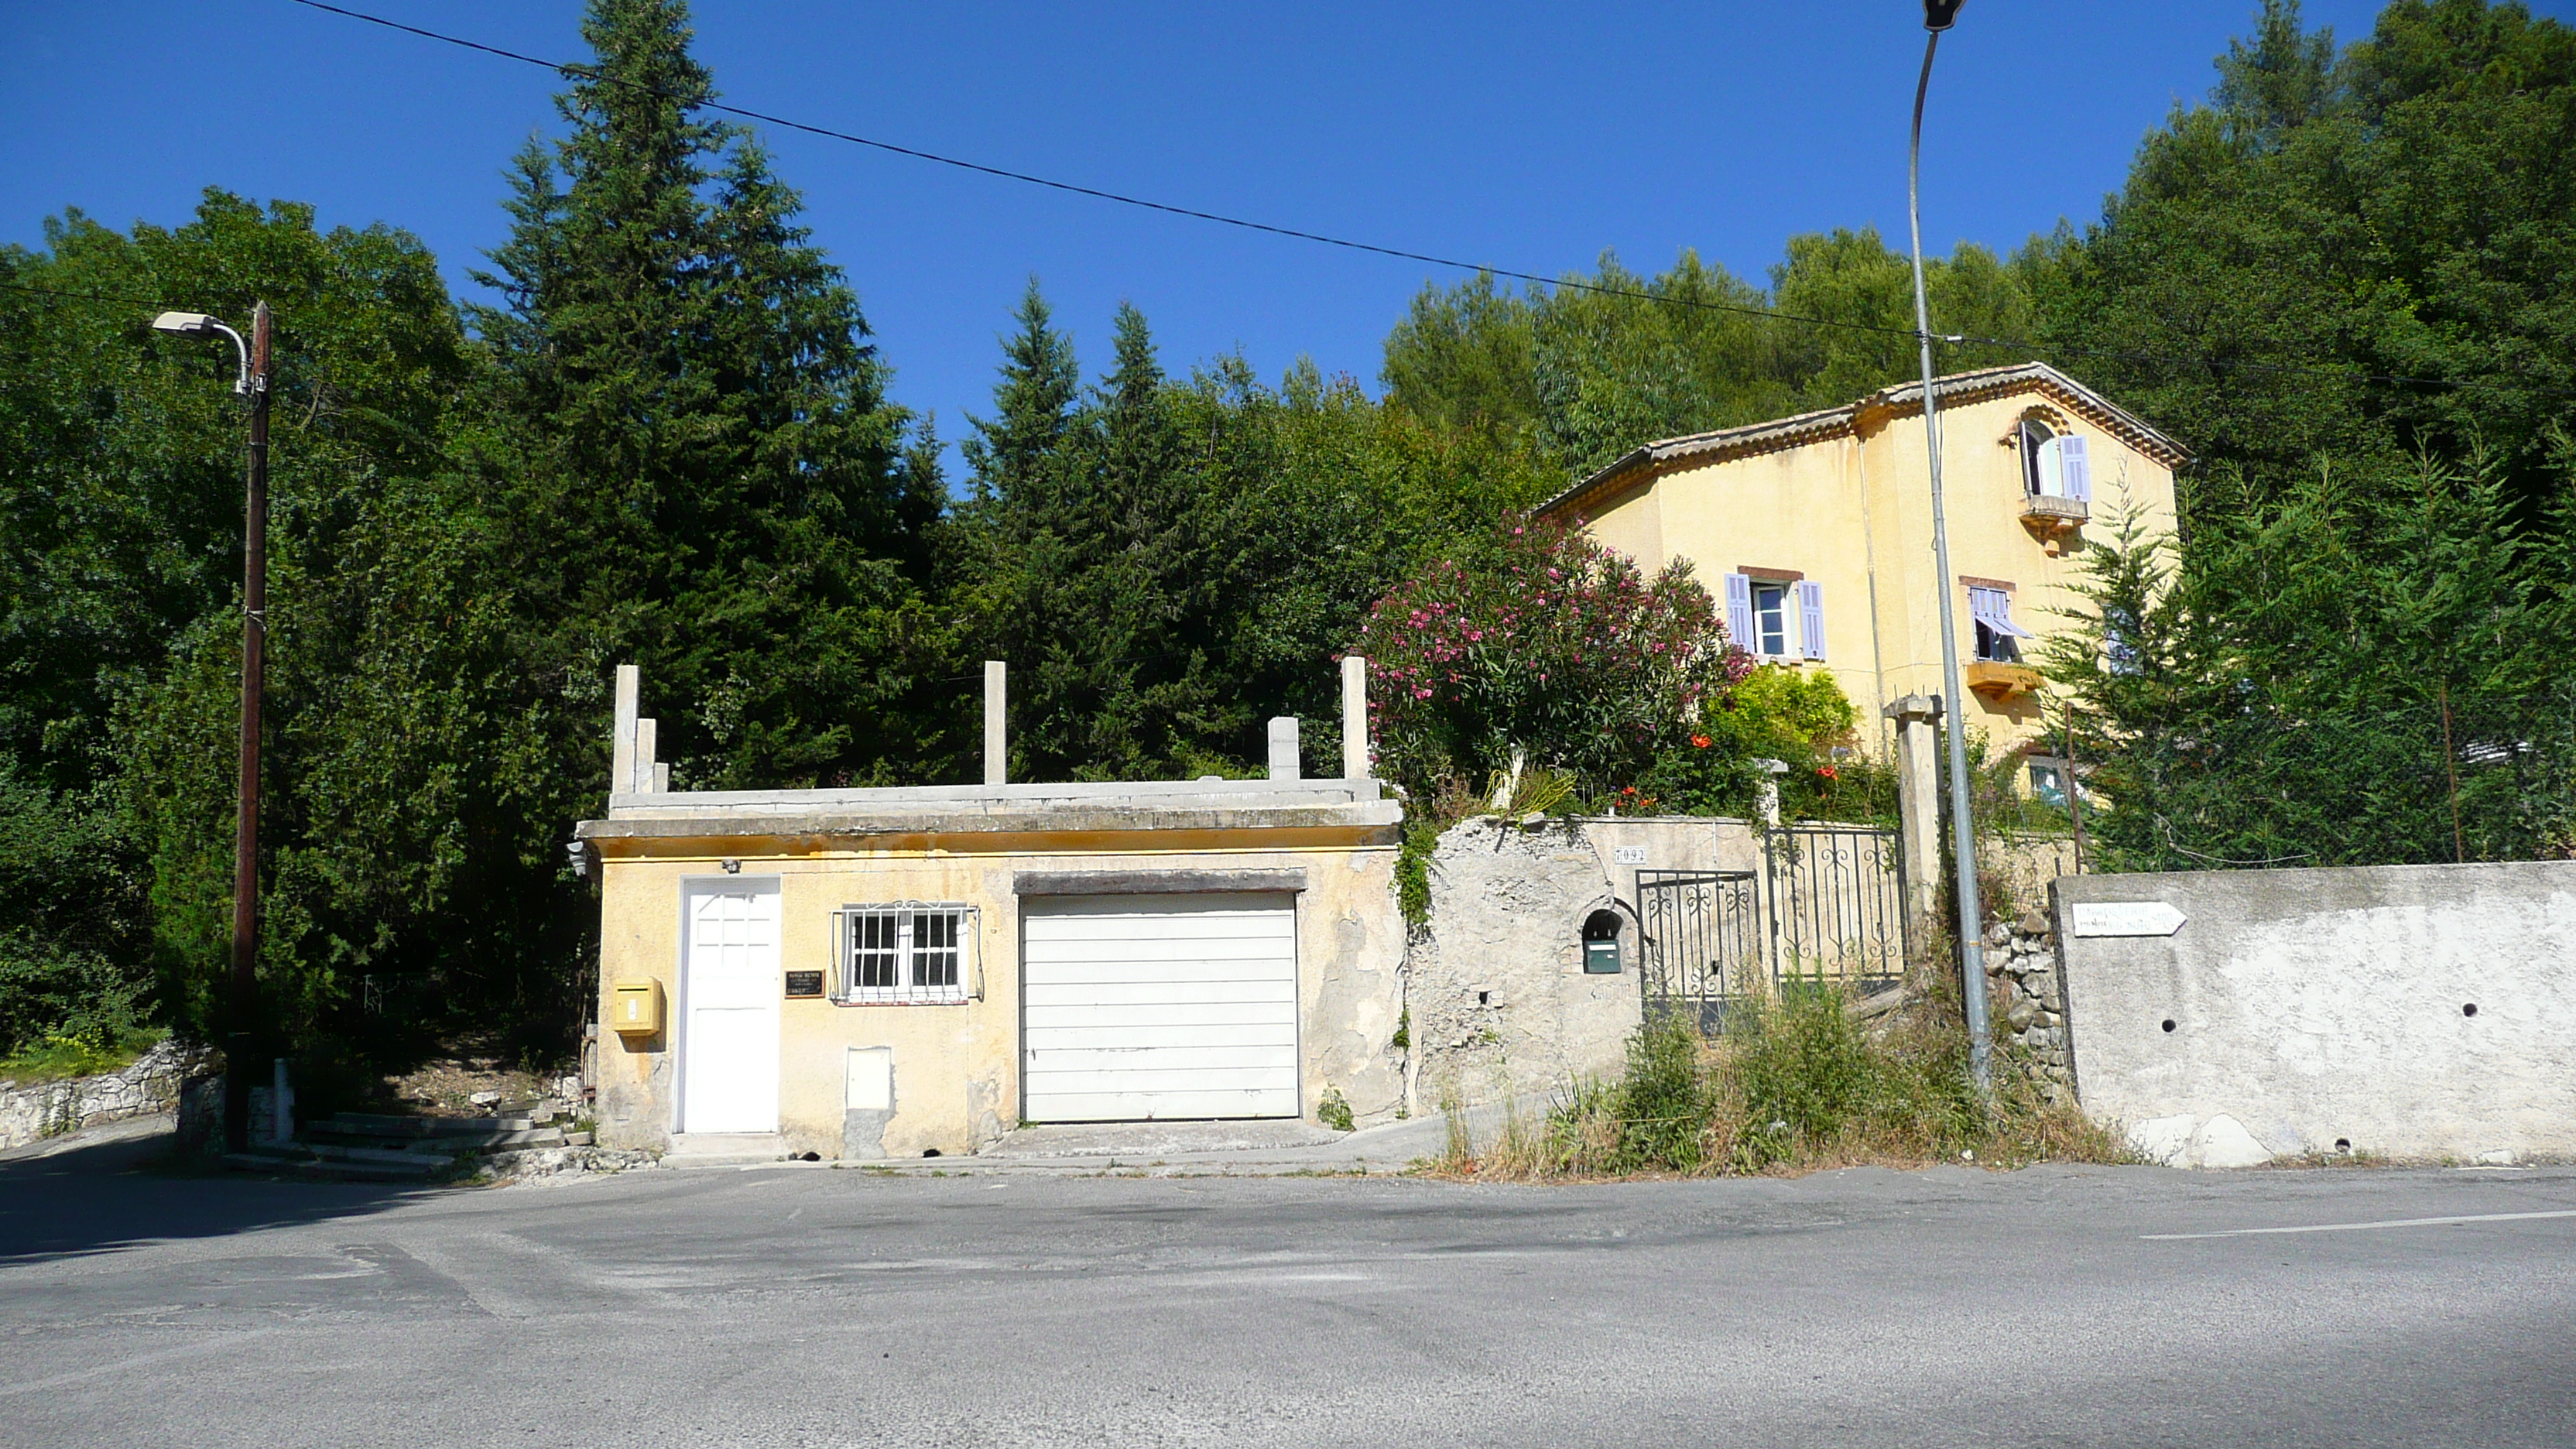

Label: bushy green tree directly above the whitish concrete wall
[2045,444,2576,869]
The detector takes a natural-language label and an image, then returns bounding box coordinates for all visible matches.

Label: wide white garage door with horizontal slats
[1020,895,1298,1122]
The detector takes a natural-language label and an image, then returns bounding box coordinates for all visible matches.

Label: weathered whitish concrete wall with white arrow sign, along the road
[2056,862,2576,1166]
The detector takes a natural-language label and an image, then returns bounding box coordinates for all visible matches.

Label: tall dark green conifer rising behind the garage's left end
[469,0,956,799]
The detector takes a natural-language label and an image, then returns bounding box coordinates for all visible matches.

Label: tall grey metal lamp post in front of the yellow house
[1906,0,1994,1096]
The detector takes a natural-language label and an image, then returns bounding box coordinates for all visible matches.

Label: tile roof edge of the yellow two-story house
[1535,361,2192,516]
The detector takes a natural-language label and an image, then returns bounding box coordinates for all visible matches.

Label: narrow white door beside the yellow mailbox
[680,882,780,1132]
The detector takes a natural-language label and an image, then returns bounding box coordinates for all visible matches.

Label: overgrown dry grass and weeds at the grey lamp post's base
[1432,969,2136,1181]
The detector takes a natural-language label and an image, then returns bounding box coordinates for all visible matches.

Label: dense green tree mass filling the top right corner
[2017,0,2576,508]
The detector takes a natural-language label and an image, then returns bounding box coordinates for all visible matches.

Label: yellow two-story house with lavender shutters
[1538,364,2190,796]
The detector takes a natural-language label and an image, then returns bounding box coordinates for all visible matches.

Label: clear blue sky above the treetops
[15,0,2576,456]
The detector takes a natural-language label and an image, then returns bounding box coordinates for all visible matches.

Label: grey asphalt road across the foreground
[0,1129,2576,1449]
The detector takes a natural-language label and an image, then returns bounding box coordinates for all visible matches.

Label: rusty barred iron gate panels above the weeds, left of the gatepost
[1636,825,1909,1031]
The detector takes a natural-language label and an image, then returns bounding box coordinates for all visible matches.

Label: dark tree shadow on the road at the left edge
[0,1129,454,1266]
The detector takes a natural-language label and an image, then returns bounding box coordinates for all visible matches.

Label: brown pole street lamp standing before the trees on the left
[152,302,268,1153]
